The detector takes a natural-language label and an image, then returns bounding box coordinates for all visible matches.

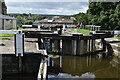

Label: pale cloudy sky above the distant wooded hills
[5,0,88,15]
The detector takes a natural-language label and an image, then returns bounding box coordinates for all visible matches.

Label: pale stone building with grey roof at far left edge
[0,0,17,30]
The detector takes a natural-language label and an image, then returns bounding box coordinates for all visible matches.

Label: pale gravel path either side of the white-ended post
[0,37,38,54]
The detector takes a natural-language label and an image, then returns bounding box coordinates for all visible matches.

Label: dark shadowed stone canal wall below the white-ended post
[2,53,42,76]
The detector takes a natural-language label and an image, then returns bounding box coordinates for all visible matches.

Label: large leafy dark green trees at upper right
[87,2,120,30]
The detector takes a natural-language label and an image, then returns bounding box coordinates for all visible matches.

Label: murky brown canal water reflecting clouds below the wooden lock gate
[48,55,120,80]
